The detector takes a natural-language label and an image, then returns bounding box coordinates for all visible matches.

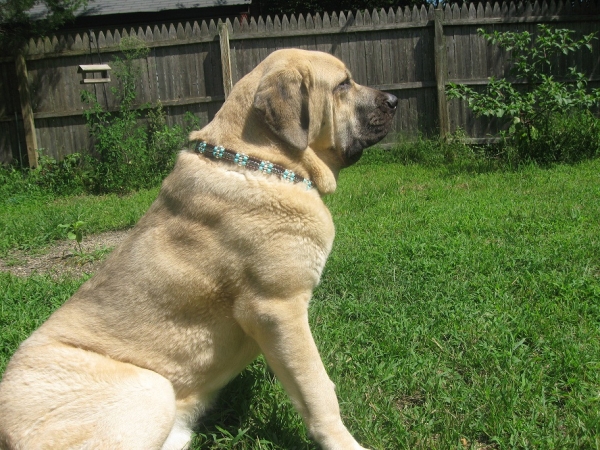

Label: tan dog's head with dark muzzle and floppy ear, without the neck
[253,49,398,168]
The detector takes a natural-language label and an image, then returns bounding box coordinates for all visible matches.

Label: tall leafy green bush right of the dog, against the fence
[448,25,600,162]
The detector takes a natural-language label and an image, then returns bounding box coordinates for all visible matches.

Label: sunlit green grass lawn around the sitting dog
[0,154,600,450]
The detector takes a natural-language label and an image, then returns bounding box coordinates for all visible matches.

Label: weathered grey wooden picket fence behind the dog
[0,0,600,164]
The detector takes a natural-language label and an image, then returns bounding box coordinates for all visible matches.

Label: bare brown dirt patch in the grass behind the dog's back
[0,230,130,278]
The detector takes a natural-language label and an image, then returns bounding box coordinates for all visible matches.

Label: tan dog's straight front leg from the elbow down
[237,296,364,450]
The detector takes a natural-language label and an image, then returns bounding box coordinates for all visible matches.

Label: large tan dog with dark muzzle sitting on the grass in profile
[0,50,397,450]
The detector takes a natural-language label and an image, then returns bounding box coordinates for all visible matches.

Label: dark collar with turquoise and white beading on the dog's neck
[194,141,317,190]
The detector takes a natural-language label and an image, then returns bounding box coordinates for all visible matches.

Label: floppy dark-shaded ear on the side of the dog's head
[254,68,309,150]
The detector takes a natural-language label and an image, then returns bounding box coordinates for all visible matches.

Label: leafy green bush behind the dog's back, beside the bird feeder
[82,38,197,193]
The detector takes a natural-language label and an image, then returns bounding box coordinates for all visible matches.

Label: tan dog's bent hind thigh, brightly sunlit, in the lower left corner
[0,344,177,450]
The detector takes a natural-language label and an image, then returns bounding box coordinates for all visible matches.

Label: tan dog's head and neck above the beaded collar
[191,49,398,194]
